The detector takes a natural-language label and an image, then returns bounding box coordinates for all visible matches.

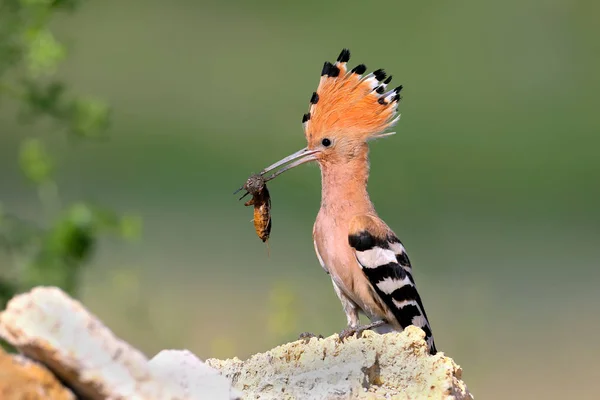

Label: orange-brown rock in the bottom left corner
[0,348,75,400]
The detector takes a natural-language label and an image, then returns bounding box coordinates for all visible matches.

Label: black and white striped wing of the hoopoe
[348,231,437,354]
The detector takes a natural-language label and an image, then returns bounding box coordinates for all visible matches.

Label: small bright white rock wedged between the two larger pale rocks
[149,350,241,400]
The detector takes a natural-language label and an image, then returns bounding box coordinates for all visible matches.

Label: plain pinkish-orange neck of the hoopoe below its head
[321,145,374,217]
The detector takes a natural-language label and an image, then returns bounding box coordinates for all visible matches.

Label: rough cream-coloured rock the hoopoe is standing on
[206,326,473,400]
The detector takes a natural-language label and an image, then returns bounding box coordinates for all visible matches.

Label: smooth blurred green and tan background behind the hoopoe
[0,0,600,399]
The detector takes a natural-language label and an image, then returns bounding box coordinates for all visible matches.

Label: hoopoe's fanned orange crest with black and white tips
[302,49,402,141]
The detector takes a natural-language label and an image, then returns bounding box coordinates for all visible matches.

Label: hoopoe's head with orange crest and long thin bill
[253,49,402,180]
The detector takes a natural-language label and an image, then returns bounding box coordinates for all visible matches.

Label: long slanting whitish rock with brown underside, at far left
[0,287,239,400]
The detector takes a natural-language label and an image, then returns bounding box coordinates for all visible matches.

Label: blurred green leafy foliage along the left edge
[0,0,141,309]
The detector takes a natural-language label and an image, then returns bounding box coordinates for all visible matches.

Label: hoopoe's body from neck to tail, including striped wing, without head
[313,141,436,353]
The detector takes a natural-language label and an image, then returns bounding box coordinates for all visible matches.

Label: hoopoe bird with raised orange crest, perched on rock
[251,49,437,354]
